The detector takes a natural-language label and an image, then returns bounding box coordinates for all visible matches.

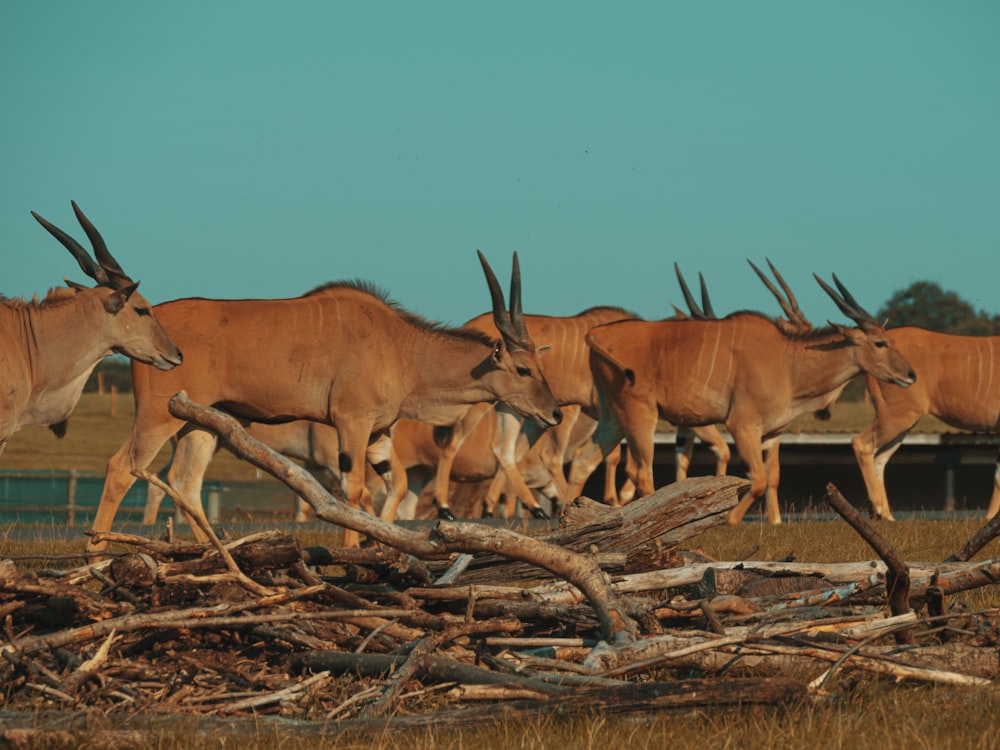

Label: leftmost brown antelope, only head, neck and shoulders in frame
[0,202,181,453]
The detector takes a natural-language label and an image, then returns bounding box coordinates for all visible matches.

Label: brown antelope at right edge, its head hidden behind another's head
[851,326,1000,521]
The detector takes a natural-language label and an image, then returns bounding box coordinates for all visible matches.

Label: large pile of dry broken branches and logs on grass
[0,396,1000,739]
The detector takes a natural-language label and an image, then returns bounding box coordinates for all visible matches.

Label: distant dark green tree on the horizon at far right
[875,281,1000,336]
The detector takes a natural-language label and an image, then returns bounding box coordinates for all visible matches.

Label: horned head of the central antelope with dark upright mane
[476,250,562,427]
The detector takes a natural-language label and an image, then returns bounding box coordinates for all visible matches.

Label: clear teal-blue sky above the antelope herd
[0,0,1000,323]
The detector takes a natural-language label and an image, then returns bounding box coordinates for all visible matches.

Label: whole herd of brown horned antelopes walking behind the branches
[0,203,1000,552]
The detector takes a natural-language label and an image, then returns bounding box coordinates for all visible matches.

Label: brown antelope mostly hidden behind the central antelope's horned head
[422,307,635,518]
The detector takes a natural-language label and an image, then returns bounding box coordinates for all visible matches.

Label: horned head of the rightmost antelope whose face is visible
[813,274,917,388]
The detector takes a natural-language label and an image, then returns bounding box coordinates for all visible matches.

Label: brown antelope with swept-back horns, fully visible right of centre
[587,276,916,524]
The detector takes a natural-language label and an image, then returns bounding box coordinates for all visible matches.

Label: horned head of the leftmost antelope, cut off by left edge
[31,201,183,370]
